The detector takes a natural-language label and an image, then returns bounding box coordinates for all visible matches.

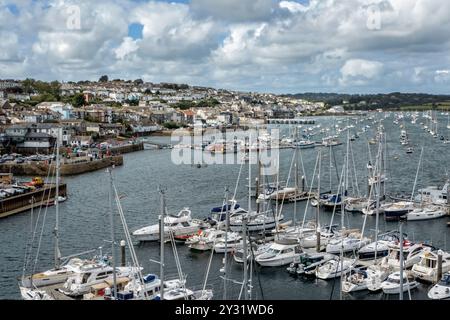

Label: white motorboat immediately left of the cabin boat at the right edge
[381,240,431,270]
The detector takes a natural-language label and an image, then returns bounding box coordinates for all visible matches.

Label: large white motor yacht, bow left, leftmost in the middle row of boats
[133,208,201,242]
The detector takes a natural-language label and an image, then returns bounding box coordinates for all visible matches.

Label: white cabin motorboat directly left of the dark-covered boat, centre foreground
[255,241,302,267]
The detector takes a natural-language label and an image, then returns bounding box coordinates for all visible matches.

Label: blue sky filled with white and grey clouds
[0,0,450,94]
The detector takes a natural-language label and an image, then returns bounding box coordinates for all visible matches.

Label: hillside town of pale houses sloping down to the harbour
[0,76,326,154]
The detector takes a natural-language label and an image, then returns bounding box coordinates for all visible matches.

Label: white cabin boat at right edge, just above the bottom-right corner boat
[412,250,450,282]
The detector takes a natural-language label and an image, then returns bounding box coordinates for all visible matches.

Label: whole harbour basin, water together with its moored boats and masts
[0,112,450,300]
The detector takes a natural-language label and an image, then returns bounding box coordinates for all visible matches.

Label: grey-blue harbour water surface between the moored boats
[0,116,450,300]
